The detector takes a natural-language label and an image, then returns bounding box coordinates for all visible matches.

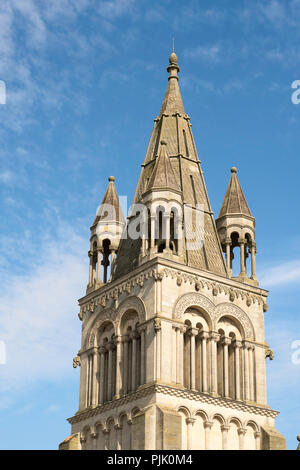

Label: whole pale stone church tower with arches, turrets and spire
[60,52,285,450]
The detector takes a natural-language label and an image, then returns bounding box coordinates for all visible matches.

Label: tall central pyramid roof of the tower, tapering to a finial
[114,52,227,279]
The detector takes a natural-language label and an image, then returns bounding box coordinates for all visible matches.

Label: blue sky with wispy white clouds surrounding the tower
[0,0,300,449]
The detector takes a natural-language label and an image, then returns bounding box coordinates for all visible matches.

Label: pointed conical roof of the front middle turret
[147,140,180,191]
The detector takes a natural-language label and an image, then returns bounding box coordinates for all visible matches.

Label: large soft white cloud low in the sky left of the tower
[0,226,87,400]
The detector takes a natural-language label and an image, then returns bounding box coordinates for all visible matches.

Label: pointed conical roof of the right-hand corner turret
[218,167,252,219]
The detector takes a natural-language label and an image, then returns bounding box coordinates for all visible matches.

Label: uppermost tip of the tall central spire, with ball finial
[159,51,185,116]
